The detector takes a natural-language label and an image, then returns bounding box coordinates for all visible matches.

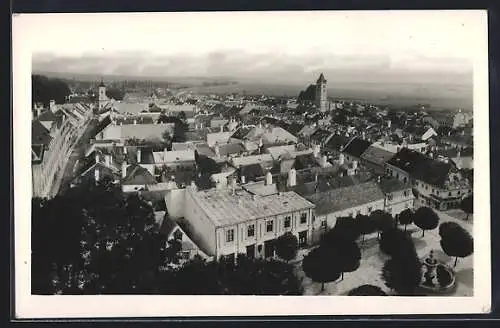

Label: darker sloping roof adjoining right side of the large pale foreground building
[305,181,384,215]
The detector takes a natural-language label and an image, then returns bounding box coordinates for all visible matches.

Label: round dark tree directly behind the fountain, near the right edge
[439,222,474,266]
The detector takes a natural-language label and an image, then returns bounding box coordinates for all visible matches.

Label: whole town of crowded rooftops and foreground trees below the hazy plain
[31,74,474,296]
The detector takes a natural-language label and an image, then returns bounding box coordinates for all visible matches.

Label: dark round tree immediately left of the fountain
[382,253,422,296]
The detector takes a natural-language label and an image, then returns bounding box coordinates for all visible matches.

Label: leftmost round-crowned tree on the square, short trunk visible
[302,246,340,292]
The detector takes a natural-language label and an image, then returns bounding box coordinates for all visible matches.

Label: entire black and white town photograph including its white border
[13,10,491,318]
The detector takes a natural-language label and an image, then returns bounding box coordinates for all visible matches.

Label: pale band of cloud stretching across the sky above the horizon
[33,49,471,83]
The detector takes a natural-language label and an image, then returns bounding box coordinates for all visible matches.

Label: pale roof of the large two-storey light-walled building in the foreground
[186,189,314,227]
